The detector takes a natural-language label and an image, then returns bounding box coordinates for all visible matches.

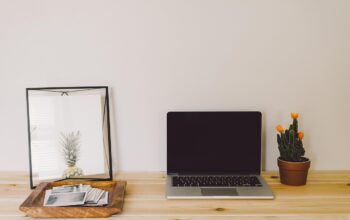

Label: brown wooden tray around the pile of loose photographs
[19,180,126,218]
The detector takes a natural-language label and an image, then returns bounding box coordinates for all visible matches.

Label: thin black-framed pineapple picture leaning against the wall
[26,86,113,188]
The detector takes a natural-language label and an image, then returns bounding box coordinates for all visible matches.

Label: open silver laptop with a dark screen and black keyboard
[166,112,274,199]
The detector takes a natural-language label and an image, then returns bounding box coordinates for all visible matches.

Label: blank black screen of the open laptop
[167,112,261,174]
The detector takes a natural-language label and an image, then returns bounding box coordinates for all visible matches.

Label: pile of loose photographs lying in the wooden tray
[44,184,108,206]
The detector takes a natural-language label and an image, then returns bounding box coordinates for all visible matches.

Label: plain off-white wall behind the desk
[0,0,350,171]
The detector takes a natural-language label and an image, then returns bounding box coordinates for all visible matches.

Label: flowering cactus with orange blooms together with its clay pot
[276,112,310,186]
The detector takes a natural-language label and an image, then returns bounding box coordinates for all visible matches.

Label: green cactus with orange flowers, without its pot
[276,113,308,162]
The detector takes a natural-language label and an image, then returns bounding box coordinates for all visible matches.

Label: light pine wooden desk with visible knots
[0,171,350,220]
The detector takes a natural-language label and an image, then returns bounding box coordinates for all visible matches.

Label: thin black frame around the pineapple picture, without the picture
[26,86,113,189]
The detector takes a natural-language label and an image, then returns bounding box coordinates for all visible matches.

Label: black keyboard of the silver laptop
[173,176,262,187]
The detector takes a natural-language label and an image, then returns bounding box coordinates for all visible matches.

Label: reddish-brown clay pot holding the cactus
[277,158,311,186]
